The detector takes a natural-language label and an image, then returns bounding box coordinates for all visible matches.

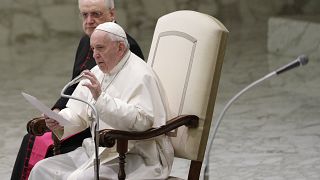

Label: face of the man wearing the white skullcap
[90,30,124,73]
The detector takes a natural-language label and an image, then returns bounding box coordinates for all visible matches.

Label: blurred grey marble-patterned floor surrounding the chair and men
[0,18,320,180]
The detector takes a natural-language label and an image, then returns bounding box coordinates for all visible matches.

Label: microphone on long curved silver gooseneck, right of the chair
[203,55,309,180]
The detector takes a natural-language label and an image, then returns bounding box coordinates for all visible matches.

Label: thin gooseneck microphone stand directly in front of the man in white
[61,80,100,180]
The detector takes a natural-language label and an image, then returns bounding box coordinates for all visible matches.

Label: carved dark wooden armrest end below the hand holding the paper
[27,117,50,136]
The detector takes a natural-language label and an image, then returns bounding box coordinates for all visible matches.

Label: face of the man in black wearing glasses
[79,0,115,36]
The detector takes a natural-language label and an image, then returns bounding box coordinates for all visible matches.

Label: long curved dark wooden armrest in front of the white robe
[99,115,199,148]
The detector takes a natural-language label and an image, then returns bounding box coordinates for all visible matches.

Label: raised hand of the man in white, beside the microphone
[82,70,102,100]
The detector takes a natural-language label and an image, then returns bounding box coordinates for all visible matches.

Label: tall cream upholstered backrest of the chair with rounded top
[148,10,228,161]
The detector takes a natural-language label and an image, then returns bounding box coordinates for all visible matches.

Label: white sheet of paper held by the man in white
[21,92,78,126]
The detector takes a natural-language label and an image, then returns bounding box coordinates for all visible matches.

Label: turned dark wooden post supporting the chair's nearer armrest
[117,140,128,180]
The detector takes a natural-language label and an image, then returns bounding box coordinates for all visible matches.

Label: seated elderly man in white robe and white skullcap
[29,22,173,180]
